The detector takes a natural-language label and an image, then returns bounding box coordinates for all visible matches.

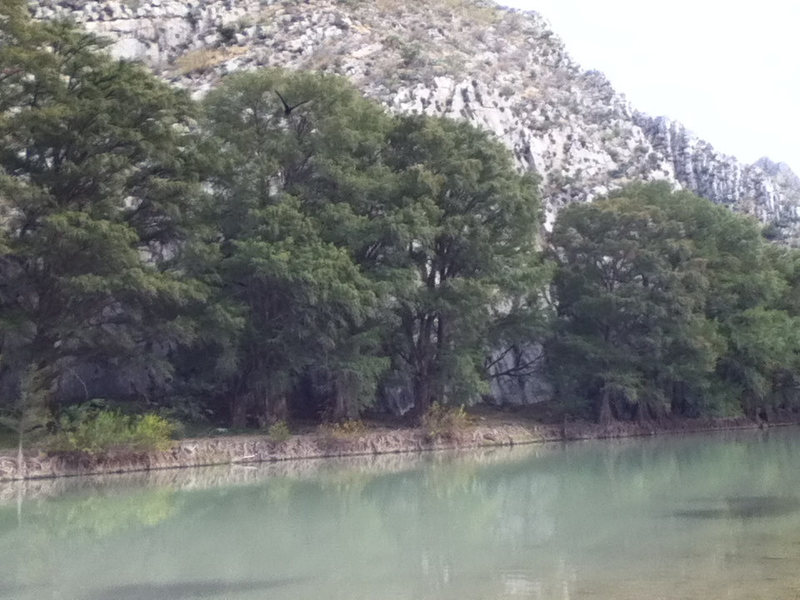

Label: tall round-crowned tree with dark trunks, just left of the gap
[377,116,545,415]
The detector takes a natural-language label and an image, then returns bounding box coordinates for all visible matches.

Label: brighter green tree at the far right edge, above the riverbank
[656,186,800,417]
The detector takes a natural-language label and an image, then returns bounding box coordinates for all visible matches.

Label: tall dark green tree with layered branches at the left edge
[0,11,202,420]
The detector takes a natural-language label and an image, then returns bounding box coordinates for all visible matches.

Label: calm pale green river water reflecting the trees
[0,429,800,600]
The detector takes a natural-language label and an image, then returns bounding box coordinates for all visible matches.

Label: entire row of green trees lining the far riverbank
[0,10,800,447]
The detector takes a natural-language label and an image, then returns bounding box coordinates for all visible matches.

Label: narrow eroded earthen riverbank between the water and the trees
[0,413,800,481]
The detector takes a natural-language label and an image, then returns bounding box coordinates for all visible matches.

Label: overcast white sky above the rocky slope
[498,0,800,174]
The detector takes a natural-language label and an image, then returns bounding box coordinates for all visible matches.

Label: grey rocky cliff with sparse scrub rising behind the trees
[31,0,800,233]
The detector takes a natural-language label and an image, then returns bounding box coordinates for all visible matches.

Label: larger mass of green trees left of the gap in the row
[0,9,543,436]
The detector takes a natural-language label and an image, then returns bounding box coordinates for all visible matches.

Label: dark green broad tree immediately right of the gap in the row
[550,185,720,423]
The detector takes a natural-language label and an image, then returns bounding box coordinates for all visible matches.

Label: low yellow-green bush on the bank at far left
[50,407,175,454]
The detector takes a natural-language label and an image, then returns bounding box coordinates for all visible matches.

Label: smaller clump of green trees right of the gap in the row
[549,184,800,421]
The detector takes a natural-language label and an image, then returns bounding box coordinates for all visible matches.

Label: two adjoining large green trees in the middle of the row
[196,70,544,424]
